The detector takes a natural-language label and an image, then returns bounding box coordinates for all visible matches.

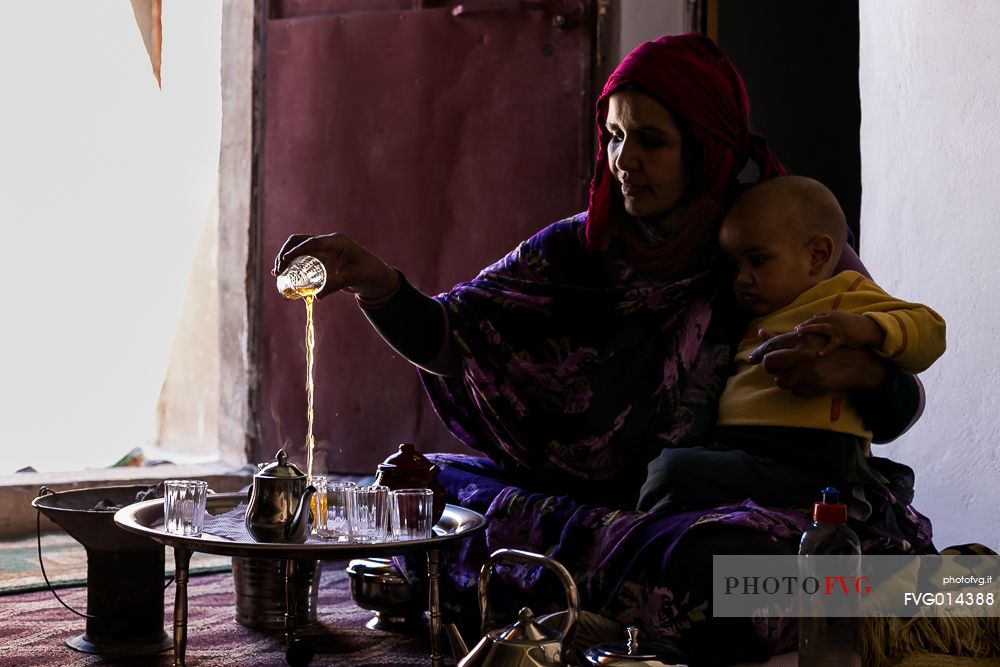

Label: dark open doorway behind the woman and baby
[700,0,861,248]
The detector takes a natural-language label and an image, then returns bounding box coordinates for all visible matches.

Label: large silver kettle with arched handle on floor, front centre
[447,549,580,667]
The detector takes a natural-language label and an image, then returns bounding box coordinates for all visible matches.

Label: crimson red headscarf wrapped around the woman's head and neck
[587,33,785,277]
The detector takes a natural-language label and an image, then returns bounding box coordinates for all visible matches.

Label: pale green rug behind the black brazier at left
[0,531,232,596]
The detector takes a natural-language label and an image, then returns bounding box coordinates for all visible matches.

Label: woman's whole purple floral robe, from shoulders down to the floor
[405,214,933,663]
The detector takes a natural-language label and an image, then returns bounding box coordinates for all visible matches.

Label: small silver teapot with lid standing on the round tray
[246,449,316,544]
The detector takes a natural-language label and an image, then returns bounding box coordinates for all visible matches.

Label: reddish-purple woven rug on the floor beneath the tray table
[0,562,430,667]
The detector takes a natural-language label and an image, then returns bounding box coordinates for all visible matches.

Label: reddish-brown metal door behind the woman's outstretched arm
[256,0,593,472]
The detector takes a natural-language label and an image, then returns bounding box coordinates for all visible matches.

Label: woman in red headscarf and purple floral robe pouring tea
[275,35,933,663]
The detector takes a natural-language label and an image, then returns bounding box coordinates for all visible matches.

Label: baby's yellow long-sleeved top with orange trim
[719,271,945,442]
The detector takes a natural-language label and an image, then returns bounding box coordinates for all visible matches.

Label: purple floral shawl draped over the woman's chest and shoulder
[422,214,731,505]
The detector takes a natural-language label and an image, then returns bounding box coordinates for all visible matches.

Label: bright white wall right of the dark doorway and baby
[860,0,1000,550]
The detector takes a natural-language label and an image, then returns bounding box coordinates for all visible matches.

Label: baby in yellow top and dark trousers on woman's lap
[639,176,945,518]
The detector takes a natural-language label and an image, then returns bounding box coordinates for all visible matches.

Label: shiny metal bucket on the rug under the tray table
[233,557,322,630]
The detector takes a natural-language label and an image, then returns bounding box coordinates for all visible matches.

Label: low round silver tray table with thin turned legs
[115,493,486,667]
